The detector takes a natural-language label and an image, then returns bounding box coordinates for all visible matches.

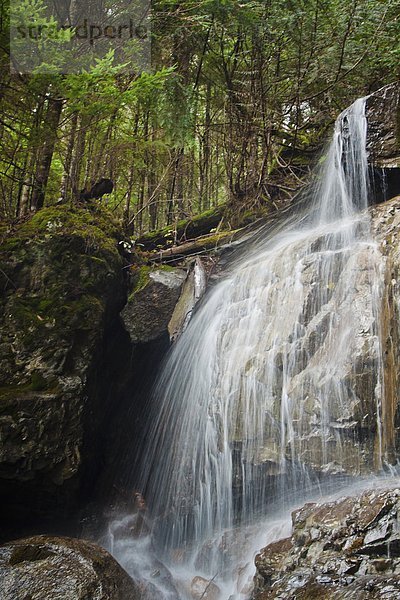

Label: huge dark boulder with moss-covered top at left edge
[0,206,125,516]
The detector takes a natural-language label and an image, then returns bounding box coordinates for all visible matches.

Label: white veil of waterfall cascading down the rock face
[105,99,390,600]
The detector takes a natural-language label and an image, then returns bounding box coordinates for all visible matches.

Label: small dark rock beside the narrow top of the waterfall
[366,83,400,169]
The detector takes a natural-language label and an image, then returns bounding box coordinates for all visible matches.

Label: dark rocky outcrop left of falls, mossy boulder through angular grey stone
[0,204,212,539]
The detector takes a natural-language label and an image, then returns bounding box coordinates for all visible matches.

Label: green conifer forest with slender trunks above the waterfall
[0,0,400,238]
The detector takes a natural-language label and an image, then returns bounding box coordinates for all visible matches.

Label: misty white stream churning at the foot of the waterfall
[102,468,400,600]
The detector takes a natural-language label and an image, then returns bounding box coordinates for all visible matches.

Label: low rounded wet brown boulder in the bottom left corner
[0,536,142,600]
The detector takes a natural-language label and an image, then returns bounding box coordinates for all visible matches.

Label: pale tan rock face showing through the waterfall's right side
[242,197,400,476]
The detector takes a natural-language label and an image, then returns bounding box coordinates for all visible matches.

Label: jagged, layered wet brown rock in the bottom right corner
[253,489,400,600]
